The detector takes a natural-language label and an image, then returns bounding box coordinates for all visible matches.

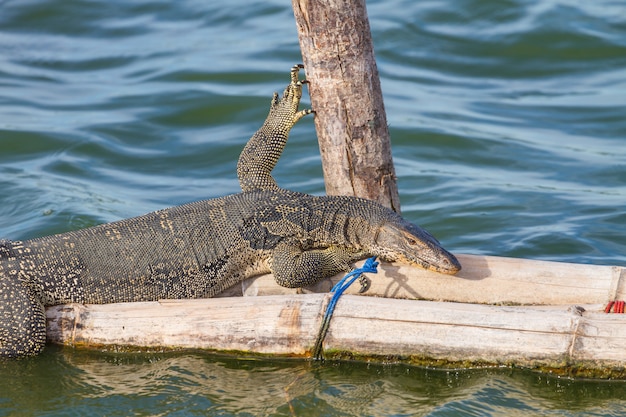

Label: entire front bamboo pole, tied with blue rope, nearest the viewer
[47,294,626,368]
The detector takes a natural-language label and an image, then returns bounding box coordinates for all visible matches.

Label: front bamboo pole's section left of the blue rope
[46,294,325,354]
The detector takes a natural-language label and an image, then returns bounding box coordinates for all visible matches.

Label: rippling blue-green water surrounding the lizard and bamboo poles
[0,0,626,416]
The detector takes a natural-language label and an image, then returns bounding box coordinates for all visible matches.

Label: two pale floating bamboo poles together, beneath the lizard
[47,255,626,378]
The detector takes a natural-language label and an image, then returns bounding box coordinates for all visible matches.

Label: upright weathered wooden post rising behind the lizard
[292,0,400,212]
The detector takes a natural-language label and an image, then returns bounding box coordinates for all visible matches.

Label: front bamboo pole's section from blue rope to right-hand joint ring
[326,296,581,366]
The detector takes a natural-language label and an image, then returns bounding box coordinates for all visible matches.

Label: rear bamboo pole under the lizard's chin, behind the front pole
[225,255,626,305]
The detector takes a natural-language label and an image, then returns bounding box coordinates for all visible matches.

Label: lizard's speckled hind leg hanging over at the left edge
[0,273,46,358]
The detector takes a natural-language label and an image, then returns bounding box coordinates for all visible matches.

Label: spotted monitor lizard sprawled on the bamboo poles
[0,67,461,357]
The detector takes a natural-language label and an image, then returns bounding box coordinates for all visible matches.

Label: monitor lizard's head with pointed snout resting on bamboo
[374,216,461,275]
